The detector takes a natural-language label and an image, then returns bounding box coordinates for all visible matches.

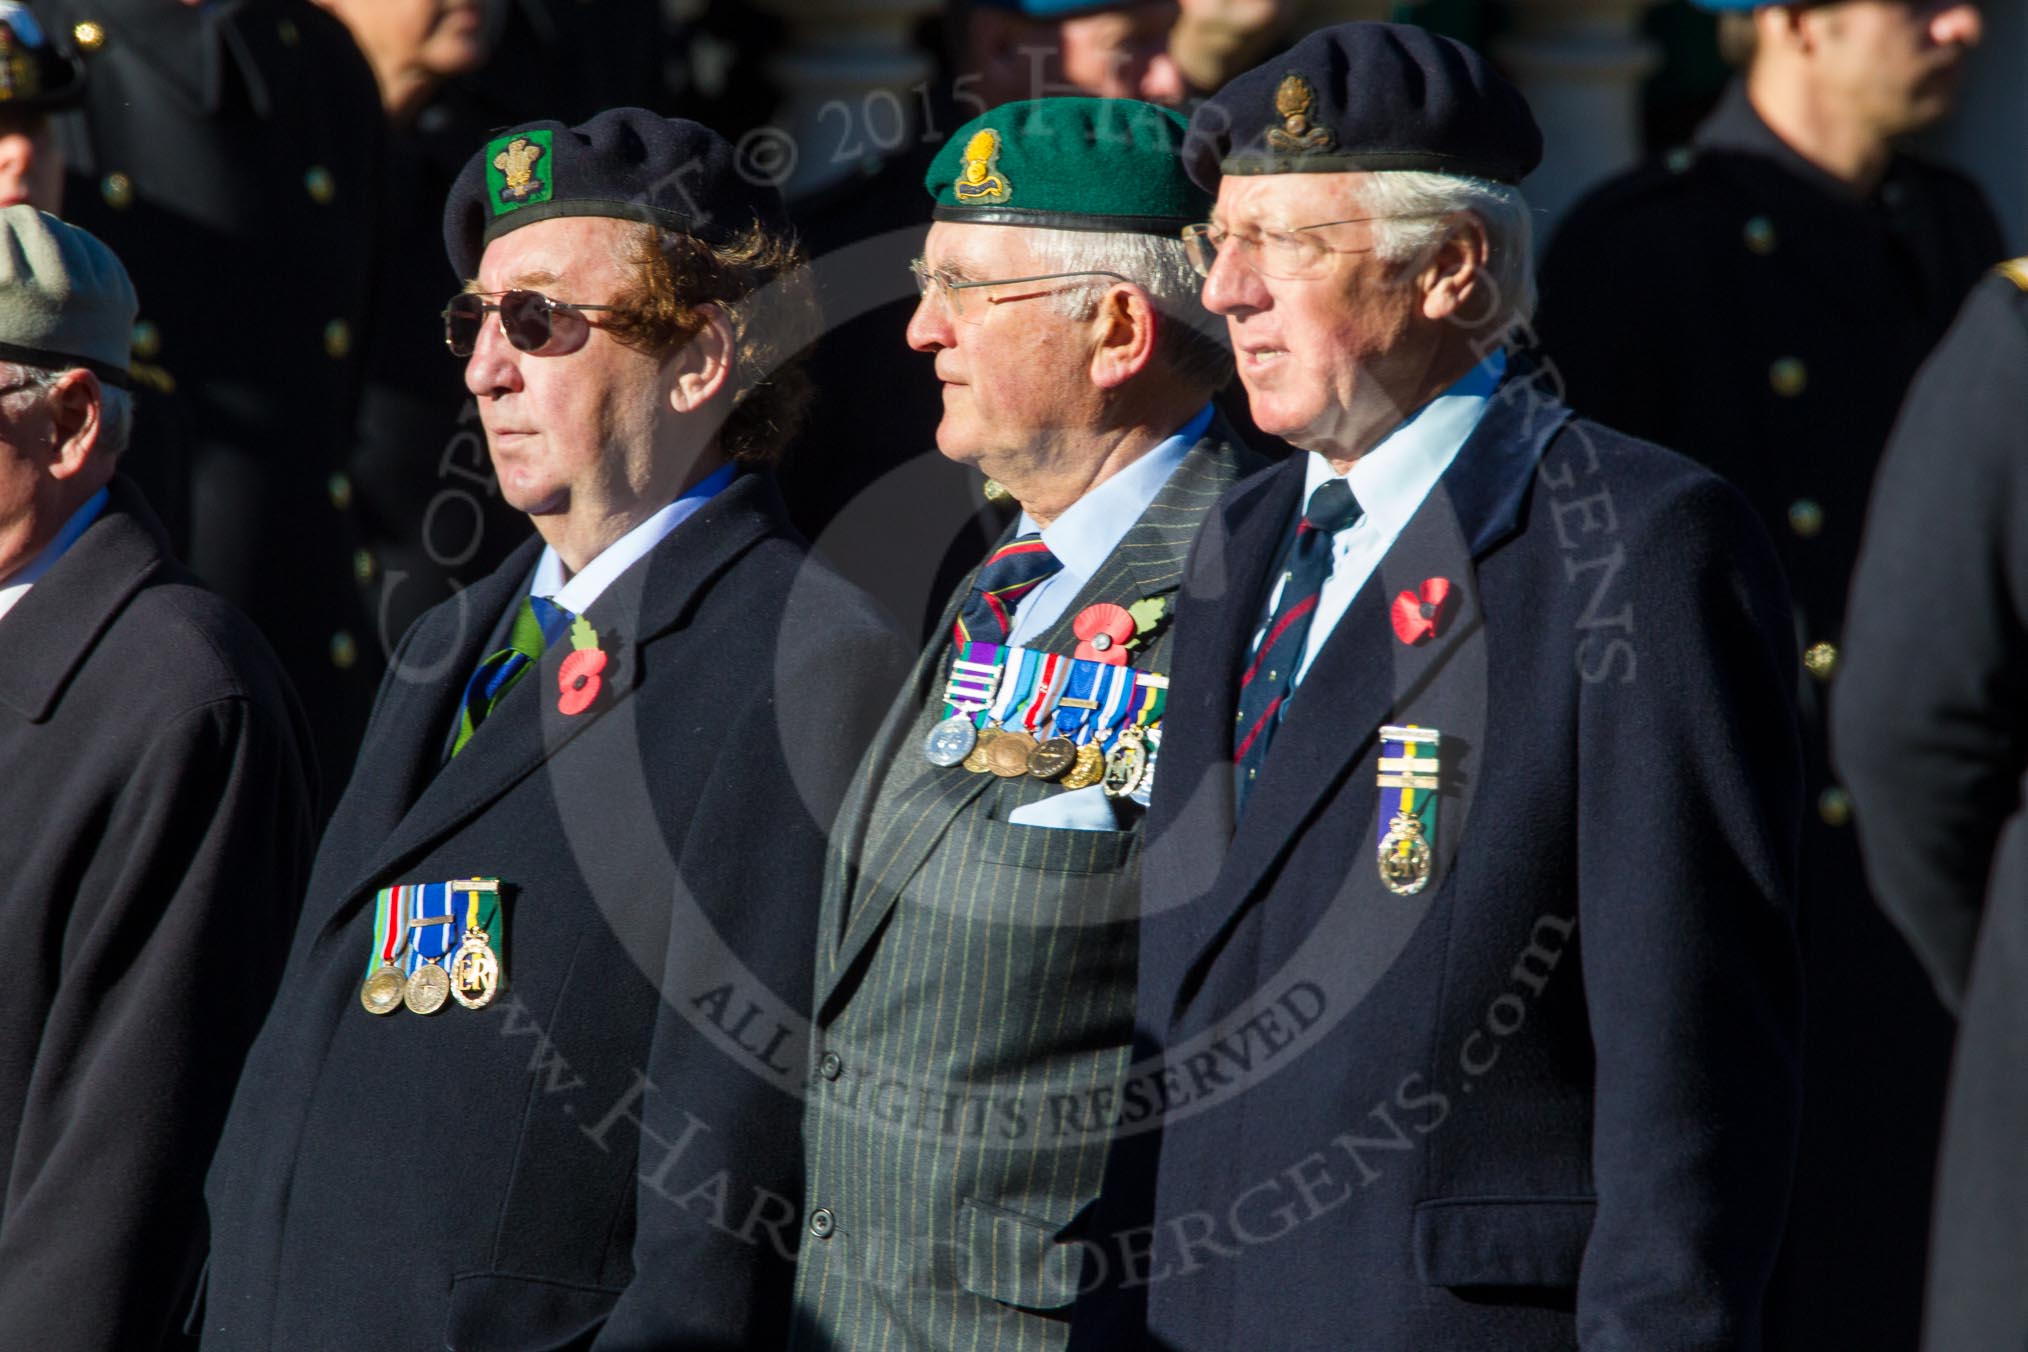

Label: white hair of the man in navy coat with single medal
[1359,170,1535,343]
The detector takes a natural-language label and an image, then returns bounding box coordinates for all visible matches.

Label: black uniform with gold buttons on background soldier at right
[1537,76,2002,1348]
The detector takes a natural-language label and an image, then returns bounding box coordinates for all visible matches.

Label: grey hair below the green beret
[1026,229,1233,391]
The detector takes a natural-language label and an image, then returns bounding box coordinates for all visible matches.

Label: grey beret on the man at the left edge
[0,207,140,389]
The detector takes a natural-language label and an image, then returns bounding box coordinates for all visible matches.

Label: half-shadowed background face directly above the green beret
[969,0,1186,105]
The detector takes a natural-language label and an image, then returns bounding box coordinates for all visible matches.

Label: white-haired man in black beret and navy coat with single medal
[1101,24,1799,1352]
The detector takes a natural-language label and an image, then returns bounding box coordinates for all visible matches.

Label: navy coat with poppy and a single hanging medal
[1119,361,1799,1352]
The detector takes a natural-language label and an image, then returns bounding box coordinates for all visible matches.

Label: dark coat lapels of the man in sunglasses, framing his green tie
[327,474,783,940]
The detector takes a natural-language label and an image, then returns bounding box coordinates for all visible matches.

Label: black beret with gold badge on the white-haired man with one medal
[1182,22,1541,193]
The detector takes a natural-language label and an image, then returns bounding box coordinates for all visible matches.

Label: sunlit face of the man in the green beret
[907,221,1097,478]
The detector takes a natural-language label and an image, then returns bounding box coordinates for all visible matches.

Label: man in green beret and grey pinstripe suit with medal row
[795,97,1257,1348]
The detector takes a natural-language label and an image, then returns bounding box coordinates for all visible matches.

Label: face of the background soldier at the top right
[1799,0,1981,138]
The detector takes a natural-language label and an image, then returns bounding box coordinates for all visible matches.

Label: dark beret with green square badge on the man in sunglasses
[444,107,789,278]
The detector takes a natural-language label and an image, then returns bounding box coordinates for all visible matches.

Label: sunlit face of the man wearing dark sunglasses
[464,217,675,539]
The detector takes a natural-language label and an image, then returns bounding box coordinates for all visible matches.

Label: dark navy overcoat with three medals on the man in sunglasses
[203,474,907,1352]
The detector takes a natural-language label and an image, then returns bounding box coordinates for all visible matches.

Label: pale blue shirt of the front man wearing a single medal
[1270,353,1507,685]
